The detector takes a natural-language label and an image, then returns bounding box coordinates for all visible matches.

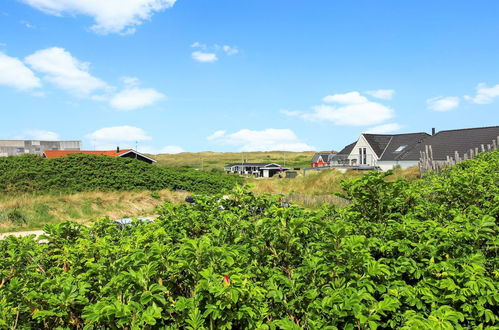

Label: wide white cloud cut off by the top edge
[21,0,176,34]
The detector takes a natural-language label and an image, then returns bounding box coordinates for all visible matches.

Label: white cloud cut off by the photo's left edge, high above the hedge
[0,52,42,90]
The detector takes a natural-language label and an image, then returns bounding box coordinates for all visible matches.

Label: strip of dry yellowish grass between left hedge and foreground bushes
[0,190,187,232]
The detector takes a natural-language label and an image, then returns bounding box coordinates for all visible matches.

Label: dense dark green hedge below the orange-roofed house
[0,154,241,193]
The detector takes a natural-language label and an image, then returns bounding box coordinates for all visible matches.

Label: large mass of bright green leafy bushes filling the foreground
[0,152,499,329]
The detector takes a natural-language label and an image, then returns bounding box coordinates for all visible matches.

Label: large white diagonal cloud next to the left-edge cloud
[25,47,110,97]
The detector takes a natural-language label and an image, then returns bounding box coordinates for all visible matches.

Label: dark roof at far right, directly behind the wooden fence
[399,126,499,160]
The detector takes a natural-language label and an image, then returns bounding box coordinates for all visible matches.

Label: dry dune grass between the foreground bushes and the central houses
[248,167,419,208]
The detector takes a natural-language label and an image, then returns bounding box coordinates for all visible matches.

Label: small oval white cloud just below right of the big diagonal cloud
[109,87,165,110]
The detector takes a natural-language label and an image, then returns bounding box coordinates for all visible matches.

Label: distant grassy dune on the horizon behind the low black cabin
[154,151,315,170]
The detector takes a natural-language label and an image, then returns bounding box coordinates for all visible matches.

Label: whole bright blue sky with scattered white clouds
[0,0,499,153]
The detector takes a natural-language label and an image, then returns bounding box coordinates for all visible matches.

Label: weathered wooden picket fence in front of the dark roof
[419,136,499,175]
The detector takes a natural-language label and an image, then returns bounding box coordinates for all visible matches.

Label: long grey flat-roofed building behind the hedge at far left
[0,140,81,157]
